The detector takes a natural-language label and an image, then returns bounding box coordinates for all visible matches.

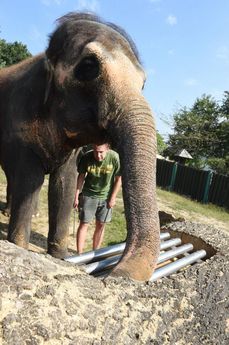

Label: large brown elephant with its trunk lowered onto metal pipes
[0,12,160,281]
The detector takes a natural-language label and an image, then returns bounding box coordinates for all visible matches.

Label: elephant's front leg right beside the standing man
[48,152,76,259]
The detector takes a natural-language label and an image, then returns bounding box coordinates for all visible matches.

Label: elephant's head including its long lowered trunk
[43,13,159,280]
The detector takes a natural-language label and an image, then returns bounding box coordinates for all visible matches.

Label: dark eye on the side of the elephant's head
[74,56,99,81]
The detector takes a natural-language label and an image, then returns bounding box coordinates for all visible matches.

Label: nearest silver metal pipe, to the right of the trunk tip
[150,249,206,281]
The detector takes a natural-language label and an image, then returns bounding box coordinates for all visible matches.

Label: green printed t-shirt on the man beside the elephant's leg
[78,150,120,200]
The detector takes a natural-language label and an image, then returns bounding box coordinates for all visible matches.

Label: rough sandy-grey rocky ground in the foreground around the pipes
[0,222,229,345]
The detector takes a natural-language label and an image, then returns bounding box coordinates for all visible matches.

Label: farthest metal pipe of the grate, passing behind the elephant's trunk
[64,232,170,265]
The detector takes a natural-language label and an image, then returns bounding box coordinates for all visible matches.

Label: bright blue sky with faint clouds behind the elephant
[0,0,229,138]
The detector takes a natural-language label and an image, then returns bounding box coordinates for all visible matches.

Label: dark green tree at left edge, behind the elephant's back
[0,39,32,68]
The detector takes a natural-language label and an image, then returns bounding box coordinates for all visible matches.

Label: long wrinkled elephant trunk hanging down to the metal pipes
[110,100,160,281]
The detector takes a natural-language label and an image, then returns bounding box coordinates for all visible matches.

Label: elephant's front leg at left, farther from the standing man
[7,148,44,249]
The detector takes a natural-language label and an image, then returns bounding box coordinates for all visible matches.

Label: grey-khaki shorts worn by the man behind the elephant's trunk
[79,194,112,223]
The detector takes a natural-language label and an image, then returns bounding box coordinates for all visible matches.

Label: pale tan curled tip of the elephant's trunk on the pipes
[109,257,155,281]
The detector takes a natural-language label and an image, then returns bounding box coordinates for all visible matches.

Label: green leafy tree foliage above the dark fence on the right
[166,92,229,174]
